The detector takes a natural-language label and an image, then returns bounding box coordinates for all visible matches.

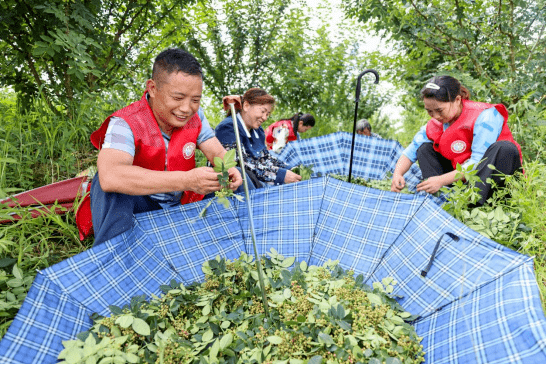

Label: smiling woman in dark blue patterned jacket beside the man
[215,88,301,187]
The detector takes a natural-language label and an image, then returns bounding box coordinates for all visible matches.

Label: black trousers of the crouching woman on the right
[417,141,522,206]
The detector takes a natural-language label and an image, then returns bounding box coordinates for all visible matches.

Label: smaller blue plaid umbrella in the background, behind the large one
[271,132,422,191]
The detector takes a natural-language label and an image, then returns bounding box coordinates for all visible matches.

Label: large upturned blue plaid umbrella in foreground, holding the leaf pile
[0,177,546,364]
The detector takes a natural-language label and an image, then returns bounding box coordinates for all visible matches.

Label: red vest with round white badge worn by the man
[76,92,203,239]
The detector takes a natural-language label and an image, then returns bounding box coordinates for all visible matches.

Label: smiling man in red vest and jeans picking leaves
[77,49,242,245]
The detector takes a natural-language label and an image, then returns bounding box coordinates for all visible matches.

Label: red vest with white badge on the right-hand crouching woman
[426,100,522,169]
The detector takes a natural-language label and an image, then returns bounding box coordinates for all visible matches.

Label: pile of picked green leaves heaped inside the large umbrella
[59,249,424,364]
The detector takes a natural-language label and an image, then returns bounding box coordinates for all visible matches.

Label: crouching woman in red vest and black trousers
[391,76,522,206]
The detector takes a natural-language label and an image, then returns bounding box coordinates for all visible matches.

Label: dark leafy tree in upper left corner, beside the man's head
[0,0,197,116]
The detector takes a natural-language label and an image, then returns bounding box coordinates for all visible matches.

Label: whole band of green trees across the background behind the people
[0,0,545,144]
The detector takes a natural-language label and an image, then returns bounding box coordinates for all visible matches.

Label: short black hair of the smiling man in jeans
[152,48,203,82]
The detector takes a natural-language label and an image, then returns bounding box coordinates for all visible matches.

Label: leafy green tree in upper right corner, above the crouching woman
[344,0,545,105]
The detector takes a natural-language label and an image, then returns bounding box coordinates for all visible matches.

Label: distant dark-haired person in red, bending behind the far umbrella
[266,113,315,153]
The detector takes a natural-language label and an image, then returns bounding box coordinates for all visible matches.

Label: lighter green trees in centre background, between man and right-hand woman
[176,0,387,137]
